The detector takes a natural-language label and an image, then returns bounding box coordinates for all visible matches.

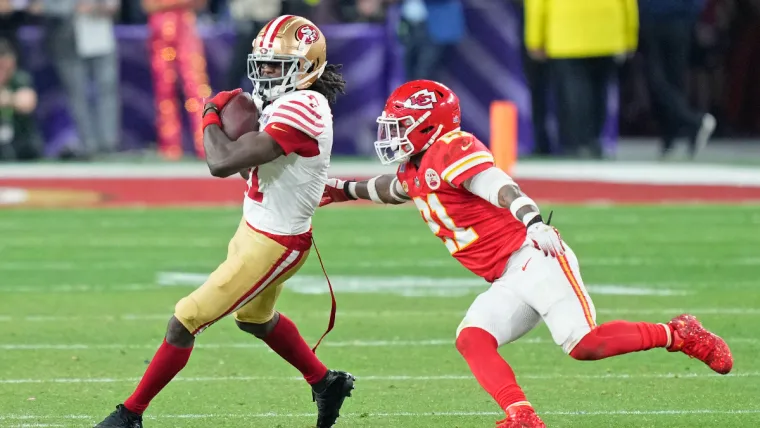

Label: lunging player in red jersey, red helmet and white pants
[320,80,733,428]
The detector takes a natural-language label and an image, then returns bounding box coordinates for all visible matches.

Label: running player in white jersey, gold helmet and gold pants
[97,15,354,428]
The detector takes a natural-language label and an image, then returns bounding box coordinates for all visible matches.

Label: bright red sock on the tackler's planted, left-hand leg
[456,327,527,410]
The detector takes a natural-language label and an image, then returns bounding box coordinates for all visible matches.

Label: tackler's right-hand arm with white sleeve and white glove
[464,166,565,257]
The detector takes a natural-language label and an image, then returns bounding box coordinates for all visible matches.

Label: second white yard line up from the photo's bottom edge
[0,372,760,385]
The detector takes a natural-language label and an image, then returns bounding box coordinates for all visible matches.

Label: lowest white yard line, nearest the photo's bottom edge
[0,409,760,421]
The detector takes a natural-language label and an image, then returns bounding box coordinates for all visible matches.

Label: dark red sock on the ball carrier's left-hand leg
[124,339,193,414]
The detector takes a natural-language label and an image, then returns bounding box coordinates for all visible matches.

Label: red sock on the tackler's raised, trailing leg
[570,321,672,360]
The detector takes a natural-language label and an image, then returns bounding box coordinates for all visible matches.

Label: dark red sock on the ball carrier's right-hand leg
[264,314,327,385]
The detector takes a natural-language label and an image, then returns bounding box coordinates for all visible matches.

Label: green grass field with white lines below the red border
[0,206,760,428]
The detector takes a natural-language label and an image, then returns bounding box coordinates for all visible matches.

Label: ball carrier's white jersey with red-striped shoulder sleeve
[243,90,333,235]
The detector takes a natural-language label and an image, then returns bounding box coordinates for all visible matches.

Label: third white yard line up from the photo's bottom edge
[0,336,760,351]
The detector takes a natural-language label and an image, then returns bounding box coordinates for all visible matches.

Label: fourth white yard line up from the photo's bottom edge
[0,307,760,323]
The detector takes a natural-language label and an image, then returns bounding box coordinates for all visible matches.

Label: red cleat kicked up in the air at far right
[668,314,734,374]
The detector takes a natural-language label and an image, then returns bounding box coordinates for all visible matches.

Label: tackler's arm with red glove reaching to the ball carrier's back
[319,174,410,206]
